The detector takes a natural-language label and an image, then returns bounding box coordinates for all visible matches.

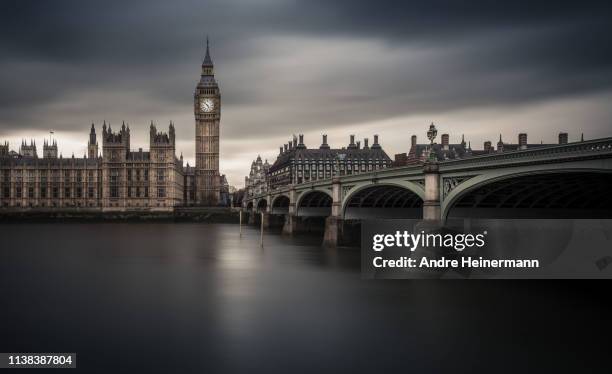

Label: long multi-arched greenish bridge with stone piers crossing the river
[243,138,612,246]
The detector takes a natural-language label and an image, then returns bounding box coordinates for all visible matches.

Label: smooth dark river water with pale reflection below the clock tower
[0,223,611,373]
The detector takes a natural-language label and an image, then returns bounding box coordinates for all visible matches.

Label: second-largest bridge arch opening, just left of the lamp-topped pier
[342,182,424,219]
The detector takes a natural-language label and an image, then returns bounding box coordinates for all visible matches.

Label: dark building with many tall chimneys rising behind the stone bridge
[267,135,391,189]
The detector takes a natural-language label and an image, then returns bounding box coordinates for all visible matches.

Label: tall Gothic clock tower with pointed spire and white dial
[193,38,221,206]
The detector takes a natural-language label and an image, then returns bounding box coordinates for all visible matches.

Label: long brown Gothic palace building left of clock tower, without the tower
[0,123,184,211]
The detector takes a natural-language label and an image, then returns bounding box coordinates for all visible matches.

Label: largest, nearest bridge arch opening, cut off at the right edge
[441,168,612,219]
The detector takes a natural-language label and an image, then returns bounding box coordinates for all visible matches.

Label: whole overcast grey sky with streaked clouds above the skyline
[0,0,612,186]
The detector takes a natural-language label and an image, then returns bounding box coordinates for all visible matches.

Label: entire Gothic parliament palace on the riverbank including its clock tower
[0,40,227,212]
